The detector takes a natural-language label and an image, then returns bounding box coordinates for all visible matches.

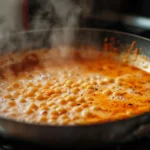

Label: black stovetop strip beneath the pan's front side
[0,139,150,150]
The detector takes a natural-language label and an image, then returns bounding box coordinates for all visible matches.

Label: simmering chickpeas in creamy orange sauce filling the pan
[0,49,150,125]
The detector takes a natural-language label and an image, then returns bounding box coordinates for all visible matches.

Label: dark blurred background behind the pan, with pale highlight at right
[28,0,150,38]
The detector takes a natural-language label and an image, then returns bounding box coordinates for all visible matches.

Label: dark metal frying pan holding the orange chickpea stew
[0,29,150,145]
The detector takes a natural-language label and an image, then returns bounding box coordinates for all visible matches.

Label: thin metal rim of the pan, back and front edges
[0,28,150,128]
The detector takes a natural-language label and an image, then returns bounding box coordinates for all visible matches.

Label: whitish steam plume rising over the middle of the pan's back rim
[33,0,81,47]
